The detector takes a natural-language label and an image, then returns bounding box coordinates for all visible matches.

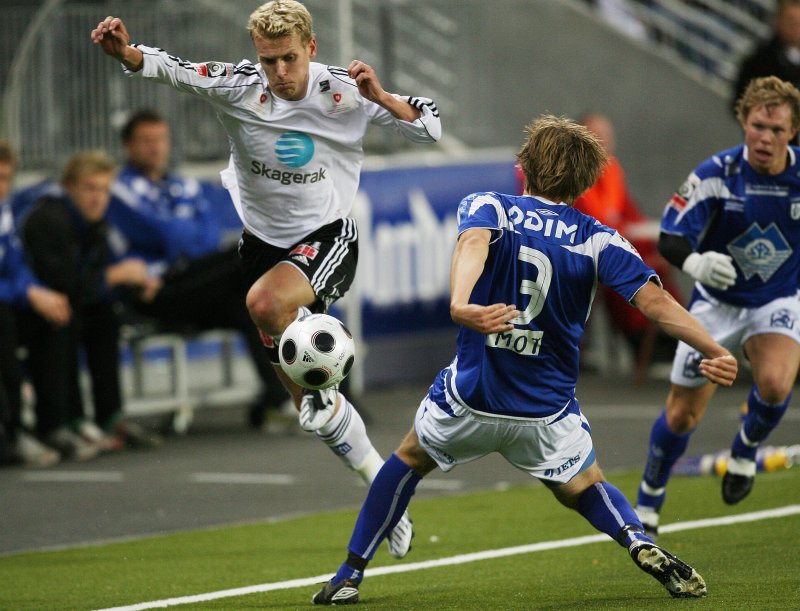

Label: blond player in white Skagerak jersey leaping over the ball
[91,0,441,557]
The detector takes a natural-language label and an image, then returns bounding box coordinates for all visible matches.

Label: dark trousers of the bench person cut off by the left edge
[0,302,22,446]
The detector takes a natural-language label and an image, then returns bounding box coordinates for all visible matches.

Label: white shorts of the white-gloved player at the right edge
[669,293,800,388]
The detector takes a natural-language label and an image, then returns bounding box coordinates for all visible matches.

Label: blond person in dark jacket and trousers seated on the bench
[20,151,160,460]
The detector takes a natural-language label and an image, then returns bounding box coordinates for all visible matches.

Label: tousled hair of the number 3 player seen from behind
[517,115,608,204]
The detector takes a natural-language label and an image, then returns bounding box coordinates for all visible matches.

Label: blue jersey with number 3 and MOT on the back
[430,193,659,418]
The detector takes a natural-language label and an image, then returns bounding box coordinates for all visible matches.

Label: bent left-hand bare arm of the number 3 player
[450,229,519,334]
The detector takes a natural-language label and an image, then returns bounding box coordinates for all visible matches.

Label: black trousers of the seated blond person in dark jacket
[20,303,122,435]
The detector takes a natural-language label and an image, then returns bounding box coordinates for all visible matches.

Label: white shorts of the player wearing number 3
[414,396,595,484]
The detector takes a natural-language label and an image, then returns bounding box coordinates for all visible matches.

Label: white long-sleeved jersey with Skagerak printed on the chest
[129,45,442,248]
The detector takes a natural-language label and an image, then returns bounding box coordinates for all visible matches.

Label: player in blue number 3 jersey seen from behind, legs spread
[312,116,737,606]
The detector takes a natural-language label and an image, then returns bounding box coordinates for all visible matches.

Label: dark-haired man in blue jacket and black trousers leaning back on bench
[108,109,296,436]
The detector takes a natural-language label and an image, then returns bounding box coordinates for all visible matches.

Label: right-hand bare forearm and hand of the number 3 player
[633,282,739,386]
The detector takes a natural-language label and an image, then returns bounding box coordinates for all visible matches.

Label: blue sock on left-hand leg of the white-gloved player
[637,411,694,511]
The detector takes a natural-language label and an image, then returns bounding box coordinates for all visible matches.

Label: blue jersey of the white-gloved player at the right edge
[661,144,800,307]
